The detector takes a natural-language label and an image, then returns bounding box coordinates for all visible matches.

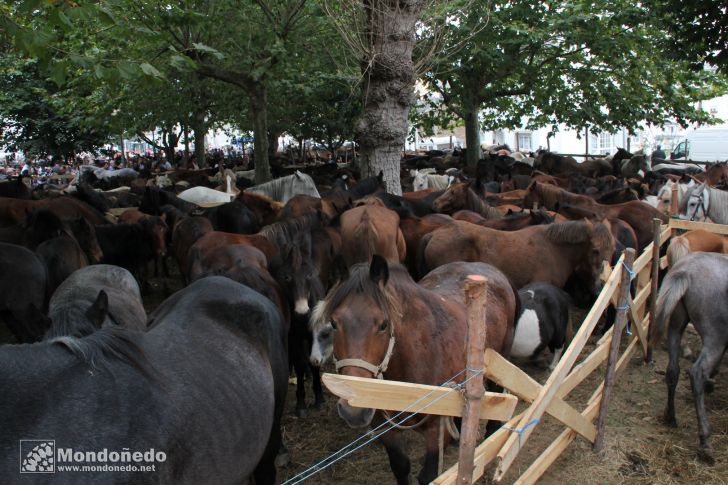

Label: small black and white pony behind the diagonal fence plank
[511,282,571,370]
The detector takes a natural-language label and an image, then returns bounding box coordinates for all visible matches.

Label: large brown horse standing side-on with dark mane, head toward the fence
[419,221,614,293]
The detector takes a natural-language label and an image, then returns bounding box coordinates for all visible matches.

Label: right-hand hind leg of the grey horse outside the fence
[690,340,725,465]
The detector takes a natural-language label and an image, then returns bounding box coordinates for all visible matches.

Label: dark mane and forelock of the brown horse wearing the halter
[310,262,409,331]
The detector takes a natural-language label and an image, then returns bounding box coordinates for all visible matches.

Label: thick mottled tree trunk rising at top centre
[356,0,423,194]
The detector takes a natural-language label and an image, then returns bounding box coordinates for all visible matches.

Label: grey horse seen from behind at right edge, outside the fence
[648,253,728,463]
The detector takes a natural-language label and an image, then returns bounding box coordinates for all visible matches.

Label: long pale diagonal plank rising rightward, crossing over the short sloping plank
[494,255,624,482]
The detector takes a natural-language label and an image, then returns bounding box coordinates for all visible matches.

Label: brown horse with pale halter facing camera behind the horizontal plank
[312,255,517,484]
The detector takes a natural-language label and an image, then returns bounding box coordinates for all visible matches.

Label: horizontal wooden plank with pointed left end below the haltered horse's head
[321,373,518,421]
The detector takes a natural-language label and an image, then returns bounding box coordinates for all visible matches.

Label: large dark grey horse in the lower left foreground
[0,277,288,484]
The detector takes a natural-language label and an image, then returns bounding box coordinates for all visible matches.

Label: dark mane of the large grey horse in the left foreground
[49,327,156,380]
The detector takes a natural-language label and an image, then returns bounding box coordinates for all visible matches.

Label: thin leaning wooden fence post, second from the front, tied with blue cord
[594,248,636,452]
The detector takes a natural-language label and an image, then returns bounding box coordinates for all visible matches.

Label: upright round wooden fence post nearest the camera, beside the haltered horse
[456,275,488,485]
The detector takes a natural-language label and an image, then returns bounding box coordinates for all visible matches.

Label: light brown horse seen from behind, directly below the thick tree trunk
[340,203,407,266]
